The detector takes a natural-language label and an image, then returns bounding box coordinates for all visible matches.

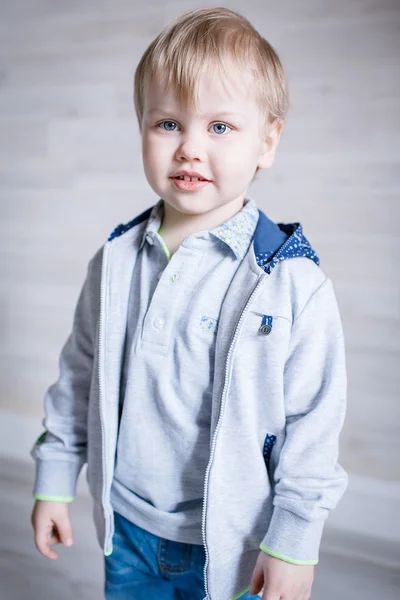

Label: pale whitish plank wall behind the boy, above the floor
[0,0,400,539]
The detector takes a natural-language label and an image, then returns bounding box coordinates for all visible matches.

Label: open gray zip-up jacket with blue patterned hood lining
[32,203,348,600]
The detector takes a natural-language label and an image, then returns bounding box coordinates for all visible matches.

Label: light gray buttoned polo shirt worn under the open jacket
[111,198,258,544]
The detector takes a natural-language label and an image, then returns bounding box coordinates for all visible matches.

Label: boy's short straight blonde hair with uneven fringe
[134,7,288,130]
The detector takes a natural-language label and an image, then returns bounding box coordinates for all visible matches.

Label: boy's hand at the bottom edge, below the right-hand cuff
[249,551,314,600]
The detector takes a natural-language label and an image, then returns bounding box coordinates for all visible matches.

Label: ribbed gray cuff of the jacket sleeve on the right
[260,506,325,565]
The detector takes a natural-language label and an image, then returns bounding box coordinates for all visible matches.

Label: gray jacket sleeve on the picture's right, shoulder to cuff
[260,277,348,565]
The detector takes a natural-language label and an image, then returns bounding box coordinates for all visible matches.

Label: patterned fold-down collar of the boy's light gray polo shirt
[139,198,259,259]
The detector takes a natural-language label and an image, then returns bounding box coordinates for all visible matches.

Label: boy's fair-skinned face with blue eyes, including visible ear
[142,70,281,215]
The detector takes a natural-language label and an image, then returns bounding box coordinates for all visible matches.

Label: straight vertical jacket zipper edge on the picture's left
[98,244,112,555]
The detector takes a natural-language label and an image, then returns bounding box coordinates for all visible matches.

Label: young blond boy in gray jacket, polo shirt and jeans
[32,8,347,600]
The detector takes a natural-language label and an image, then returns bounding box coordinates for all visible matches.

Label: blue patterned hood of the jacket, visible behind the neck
[108,207,320,273]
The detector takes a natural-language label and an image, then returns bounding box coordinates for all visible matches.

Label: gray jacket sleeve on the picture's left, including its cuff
[31,251,101,502]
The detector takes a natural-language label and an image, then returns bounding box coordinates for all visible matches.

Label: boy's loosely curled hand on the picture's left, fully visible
[31,500,74,560]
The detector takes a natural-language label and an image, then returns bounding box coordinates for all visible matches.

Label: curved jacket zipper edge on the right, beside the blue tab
[202,273,268,600]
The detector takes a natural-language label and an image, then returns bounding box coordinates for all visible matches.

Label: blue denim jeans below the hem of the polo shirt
[104,513,259,600]
